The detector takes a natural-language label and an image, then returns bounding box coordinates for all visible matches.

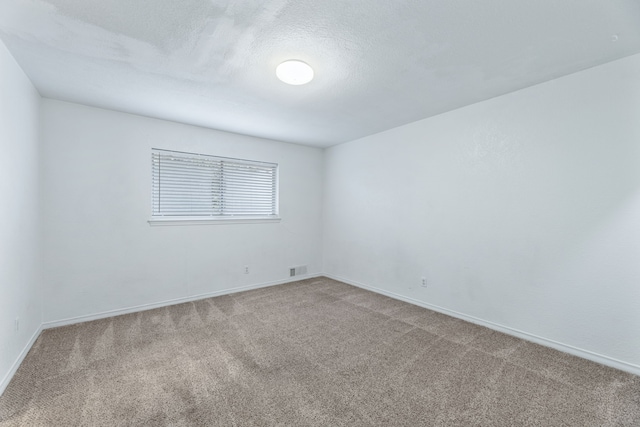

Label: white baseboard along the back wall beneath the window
[42,273,322,329]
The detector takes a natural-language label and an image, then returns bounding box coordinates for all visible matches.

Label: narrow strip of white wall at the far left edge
[0,42,42,393]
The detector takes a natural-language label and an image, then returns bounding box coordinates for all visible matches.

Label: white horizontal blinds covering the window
[151,148,278,217]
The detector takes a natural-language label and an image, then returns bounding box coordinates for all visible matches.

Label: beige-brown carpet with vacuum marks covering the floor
[0,278,640,427]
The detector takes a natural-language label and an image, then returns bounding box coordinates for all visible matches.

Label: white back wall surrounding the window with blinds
[43,99,323,322]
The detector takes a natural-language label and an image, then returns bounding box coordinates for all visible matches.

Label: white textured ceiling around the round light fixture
[0,0,640,146]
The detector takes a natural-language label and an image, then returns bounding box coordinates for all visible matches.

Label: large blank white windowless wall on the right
[324,55,640,366]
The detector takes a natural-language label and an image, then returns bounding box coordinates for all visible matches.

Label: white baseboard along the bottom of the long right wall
[324,274,640,376]
